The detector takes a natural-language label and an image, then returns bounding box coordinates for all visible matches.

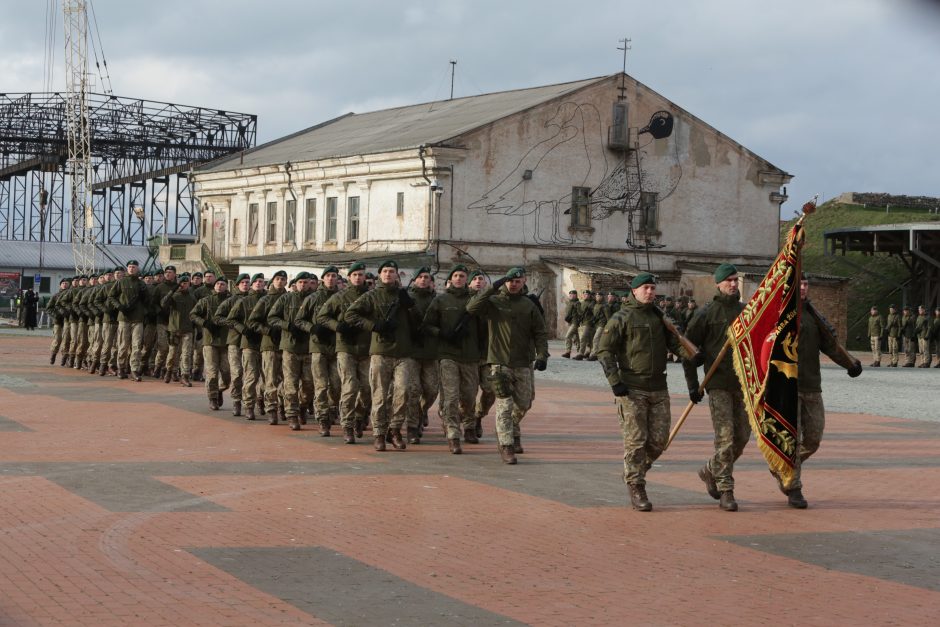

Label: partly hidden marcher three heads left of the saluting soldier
[408,267,441,444]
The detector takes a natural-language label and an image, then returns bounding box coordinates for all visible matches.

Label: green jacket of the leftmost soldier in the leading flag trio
[597,299,691,392]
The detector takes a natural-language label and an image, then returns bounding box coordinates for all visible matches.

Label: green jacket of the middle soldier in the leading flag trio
[682,292,744,390]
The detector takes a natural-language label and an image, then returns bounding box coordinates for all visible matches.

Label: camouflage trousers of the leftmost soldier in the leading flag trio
[616,389,672,486]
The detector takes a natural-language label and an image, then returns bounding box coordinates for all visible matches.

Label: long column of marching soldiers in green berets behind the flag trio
[47,260,548,464]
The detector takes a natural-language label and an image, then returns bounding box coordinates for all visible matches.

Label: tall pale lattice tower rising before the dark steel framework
[62,0,95,274]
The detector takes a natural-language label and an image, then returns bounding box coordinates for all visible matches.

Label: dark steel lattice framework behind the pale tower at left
[0,92,257,255]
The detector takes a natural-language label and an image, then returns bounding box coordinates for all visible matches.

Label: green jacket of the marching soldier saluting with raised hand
[467,285,548,368]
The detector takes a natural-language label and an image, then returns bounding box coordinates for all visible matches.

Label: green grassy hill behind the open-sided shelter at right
[781,202,940,350]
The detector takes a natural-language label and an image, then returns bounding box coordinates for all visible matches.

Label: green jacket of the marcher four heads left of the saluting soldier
[346,284,421,358]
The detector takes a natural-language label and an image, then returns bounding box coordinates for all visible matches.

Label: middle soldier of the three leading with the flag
[682,263,751,512]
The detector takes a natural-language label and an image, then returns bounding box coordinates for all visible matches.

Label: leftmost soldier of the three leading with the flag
[598,272,692,512]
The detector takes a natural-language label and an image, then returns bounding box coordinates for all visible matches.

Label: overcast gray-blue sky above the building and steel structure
[0,0,940,215]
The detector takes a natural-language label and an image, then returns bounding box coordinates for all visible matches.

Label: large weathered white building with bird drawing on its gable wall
[194,73,791,336]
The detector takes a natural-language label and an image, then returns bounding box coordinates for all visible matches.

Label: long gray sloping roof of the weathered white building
[201,74,619,172]
